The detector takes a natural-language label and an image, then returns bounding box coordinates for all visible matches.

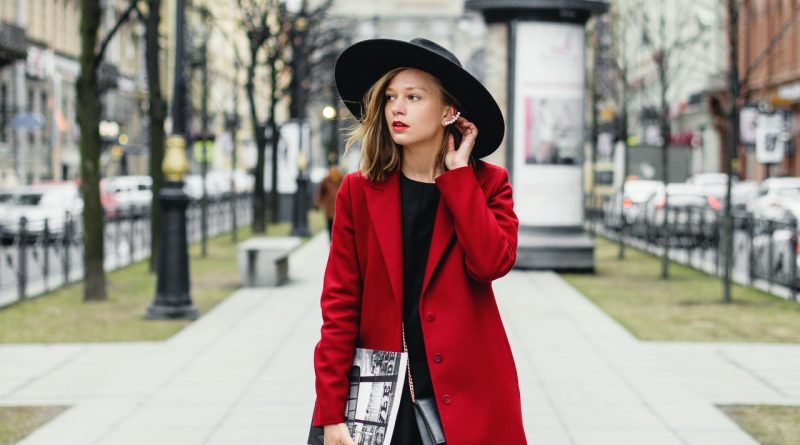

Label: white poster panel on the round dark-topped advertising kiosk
[512,22,584,228]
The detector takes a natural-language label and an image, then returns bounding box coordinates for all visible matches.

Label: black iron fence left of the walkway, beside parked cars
[0,194,252,307]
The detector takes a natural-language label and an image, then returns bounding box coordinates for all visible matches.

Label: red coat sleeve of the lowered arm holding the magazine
[313,173,363,426]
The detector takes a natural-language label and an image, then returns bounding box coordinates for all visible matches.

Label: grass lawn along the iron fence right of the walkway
[562,237,800,343]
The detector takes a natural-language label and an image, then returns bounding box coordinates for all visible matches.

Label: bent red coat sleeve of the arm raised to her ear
[436,167,519,282]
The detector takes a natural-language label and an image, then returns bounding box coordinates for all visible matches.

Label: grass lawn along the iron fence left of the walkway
[0,212,325,343]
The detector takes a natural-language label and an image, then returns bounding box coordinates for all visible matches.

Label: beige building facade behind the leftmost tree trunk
[0,0,146,185]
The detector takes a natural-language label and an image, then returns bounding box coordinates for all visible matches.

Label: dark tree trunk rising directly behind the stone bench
[246,43,268,233]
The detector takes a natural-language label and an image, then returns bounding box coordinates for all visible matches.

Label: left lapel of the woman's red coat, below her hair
[365,172,403,302]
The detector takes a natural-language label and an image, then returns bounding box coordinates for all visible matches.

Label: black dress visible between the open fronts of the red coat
[391,173,439,445]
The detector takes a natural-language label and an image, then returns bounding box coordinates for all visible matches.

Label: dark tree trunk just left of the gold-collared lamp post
[146,0,167,272]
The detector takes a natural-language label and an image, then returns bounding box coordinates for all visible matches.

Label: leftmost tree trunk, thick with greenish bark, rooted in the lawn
[76,0,106,301]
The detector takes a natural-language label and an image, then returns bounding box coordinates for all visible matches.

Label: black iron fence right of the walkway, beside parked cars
[586,200,800,301]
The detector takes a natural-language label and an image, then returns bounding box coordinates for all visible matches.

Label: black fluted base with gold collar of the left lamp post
[150,135,198,320]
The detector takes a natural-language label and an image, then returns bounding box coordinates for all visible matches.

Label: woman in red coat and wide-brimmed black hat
[313,39,526,445]
